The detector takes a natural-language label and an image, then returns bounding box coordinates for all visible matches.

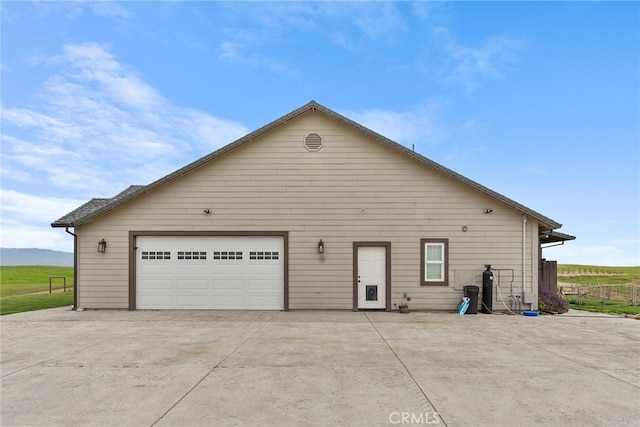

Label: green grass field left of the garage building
[0,265,74,315]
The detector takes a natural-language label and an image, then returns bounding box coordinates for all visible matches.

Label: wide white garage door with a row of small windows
[136,236,284,310]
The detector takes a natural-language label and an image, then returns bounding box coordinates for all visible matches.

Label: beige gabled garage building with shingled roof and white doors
[52,101,572,310]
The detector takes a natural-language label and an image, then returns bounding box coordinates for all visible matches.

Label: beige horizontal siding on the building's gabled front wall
[76,112,538,310]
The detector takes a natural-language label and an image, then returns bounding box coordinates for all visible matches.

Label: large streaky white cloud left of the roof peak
[2,43,248,196]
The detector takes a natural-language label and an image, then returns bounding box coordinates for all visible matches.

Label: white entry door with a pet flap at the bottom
[358,246,387,309]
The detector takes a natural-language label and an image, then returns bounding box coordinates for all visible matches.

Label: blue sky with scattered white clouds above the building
[0,1,640,265]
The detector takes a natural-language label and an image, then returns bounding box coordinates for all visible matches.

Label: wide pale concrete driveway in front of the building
[0,308,640,426]
